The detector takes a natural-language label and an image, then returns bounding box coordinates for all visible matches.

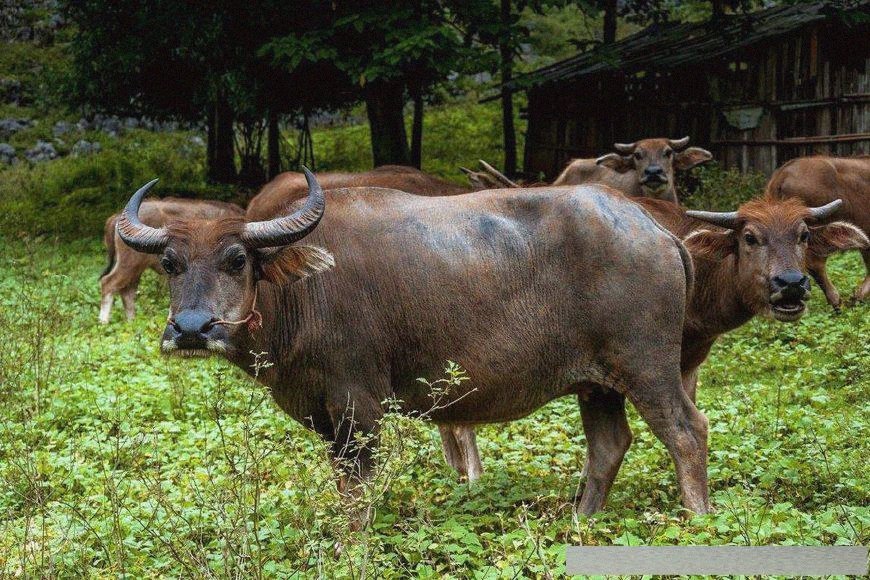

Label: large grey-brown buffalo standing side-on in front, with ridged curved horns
[118,173,708,513]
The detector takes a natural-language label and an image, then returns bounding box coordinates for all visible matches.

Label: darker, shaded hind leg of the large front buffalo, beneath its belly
[578,387,632,514]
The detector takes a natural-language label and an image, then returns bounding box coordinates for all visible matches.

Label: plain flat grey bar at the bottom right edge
[565,546,867,576]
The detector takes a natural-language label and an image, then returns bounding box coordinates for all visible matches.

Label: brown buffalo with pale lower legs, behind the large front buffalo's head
[99,197,245,324]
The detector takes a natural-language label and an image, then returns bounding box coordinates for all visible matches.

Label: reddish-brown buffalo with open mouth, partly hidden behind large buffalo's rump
[441,197,870,480]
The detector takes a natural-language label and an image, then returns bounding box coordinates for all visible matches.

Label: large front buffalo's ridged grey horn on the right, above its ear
[242,166,326,248]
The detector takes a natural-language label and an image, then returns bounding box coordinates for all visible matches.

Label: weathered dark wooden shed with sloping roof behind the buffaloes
[508,0,870,178]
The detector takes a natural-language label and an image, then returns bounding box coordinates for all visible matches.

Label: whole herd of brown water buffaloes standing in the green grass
[100,138,870,513]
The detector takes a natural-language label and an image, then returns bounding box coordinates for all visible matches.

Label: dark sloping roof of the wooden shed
[500,0,870,93]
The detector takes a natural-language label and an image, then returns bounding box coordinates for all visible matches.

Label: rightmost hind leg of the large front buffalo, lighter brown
[628,378,710,514]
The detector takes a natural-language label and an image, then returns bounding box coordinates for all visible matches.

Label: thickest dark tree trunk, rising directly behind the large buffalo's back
[365,81,411,167]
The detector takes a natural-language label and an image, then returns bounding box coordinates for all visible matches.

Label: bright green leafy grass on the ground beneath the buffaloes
[0,238,870,577]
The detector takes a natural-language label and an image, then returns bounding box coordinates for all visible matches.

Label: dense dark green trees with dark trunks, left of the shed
[66,0,780,184]
